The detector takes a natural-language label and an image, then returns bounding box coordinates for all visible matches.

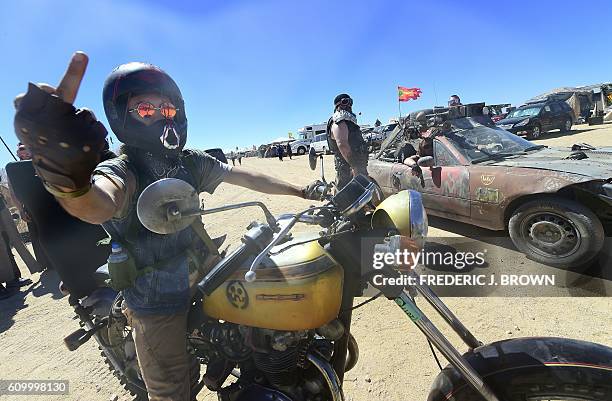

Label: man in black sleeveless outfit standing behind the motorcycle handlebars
[327,93,368,190]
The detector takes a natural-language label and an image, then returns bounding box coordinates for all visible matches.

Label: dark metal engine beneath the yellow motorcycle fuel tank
[190,320,333,401]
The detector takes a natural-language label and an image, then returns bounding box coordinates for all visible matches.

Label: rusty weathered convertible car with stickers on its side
[368,104,612,268]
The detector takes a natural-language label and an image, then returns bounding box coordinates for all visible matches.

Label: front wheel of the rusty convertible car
[508,198,604,268]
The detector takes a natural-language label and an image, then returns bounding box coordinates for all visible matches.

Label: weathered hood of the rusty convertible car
[490,147,612,180]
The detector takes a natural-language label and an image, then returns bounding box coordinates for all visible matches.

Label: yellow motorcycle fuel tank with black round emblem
[203,235,344,331]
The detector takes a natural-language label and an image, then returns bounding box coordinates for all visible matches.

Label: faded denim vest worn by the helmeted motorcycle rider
[102,159,205,315]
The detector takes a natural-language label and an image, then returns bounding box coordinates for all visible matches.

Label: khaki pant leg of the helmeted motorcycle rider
[123,308,196,401]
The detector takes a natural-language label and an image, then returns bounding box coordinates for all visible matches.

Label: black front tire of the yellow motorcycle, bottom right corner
[427,338,612,401]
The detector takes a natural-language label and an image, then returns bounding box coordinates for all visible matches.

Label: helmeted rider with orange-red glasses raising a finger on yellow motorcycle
[15,52,314,401]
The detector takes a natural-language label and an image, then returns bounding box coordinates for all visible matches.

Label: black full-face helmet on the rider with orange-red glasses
[102,62,187,155]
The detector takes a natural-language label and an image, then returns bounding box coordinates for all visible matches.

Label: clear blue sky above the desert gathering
[0,0,612,165]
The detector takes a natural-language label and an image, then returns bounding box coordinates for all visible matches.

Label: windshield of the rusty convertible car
[444,126,545,163]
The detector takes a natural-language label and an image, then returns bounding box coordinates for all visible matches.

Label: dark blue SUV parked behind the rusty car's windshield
[496,100,575,139]
